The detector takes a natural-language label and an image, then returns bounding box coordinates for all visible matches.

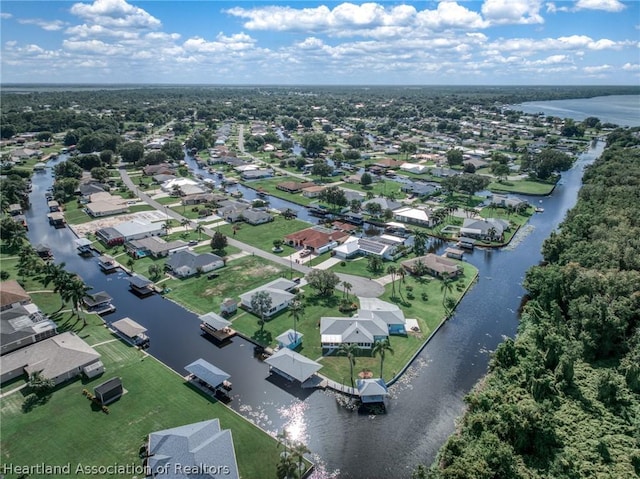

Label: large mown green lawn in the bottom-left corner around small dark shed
[0,318,279,478]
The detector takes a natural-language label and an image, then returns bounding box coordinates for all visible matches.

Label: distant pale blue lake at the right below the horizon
[511,95,640,126]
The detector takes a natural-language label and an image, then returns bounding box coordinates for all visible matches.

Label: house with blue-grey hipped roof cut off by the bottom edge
[146,418,240,479]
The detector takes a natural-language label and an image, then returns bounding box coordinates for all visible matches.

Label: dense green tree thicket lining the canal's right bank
[424,128,640,479]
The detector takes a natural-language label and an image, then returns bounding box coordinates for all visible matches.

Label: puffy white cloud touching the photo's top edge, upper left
[71,0,162,30]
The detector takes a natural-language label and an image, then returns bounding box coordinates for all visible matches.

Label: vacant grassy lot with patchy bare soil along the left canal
[163,256,289,314]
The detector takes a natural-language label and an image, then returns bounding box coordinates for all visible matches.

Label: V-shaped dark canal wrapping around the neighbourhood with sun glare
[27,142,604,478]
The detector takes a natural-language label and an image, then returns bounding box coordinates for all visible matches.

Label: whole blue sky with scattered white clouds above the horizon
[0,0,640,85]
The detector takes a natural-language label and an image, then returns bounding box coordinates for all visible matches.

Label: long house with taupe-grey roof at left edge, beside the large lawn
[0,332,101,386]
